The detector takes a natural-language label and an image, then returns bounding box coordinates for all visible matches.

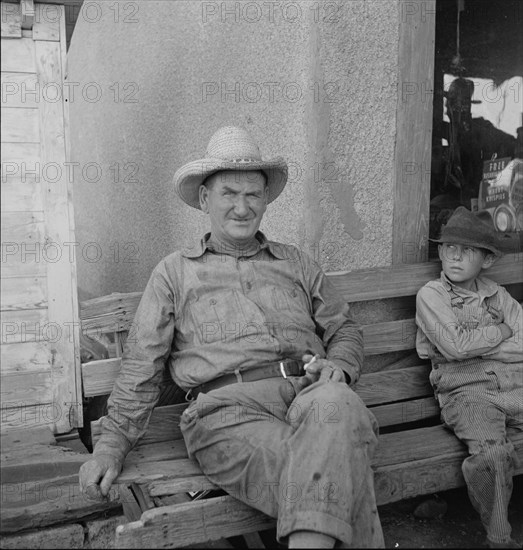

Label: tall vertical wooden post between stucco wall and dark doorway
[392,0,436,265]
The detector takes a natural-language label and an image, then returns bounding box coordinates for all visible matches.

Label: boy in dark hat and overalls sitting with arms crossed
[416,206,523,548]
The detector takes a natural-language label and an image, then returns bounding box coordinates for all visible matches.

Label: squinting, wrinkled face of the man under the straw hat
[200,170,268,245]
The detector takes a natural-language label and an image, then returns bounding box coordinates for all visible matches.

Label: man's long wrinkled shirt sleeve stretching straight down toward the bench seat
[93,264,174,464]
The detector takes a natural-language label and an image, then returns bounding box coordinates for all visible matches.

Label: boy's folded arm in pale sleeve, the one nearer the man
[416,284,504,361]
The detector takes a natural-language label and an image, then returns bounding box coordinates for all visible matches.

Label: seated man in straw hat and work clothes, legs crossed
[80,127,384,548]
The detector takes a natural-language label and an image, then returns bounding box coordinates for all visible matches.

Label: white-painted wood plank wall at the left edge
[0,0,81,433]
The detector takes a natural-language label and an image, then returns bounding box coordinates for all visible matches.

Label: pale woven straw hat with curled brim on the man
[173,126,287,209]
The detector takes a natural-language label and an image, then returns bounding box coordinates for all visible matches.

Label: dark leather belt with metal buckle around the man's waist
[187,359,303,399]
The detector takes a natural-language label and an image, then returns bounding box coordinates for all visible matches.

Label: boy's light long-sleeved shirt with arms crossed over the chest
[416,271,523,364]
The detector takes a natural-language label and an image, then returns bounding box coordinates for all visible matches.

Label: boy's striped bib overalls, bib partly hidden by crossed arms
[430,289,523,542]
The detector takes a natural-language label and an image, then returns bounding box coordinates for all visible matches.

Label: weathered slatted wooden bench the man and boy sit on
[81,254,523,548]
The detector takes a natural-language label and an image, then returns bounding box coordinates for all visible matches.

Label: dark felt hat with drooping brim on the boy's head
[430,206,503,256]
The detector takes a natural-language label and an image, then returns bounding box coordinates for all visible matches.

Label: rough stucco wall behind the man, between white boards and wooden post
[68,0,399,297]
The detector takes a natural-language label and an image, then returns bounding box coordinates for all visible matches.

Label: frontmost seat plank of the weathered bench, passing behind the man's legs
[116,434,523,548]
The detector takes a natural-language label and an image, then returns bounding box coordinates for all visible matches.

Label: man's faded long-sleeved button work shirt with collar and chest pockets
[95,232,363,462]
